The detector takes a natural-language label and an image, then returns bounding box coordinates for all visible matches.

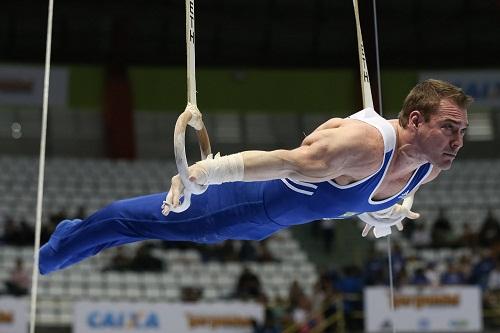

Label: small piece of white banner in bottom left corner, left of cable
[0,297,28,333]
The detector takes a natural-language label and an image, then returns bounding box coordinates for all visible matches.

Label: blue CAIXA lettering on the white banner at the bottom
[87,311,160,330]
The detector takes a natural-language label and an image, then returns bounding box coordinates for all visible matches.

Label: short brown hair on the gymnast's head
[398,79,474,128]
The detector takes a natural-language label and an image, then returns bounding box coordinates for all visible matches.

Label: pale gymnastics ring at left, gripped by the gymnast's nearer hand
[170,103,212,213]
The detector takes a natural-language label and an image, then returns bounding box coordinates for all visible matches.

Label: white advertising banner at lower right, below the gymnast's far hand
[364,286,483,332]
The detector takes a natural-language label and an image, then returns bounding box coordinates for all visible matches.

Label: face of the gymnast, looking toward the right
[418,99,468,170]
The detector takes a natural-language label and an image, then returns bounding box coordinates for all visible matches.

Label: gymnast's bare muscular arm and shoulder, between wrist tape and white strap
[242,120,382,182]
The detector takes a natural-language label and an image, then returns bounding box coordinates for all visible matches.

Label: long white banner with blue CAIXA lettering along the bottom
[73,302,263,333]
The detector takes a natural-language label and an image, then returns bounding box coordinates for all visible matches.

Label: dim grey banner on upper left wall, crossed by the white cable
[0,65,69,107]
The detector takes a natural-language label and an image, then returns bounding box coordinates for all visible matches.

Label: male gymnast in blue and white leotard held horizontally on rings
[39,80,472,274]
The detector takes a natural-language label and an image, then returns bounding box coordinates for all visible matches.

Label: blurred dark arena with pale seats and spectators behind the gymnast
[0,0,500,333]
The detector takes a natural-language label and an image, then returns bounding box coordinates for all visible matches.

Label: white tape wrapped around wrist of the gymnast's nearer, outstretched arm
[196,153,244,185]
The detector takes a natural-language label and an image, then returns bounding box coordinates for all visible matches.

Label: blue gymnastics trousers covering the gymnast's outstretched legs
[39,182,284,274]
